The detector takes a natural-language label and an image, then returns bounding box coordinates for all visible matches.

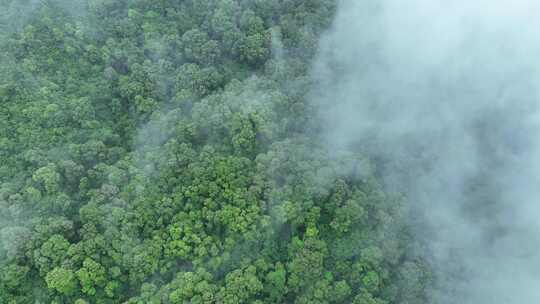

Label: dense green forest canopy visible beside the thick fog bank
[0,0,428,304]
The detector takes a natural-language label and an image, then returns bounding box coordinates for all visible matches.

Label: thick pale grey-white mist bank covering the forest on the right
[310,0,540,304]
